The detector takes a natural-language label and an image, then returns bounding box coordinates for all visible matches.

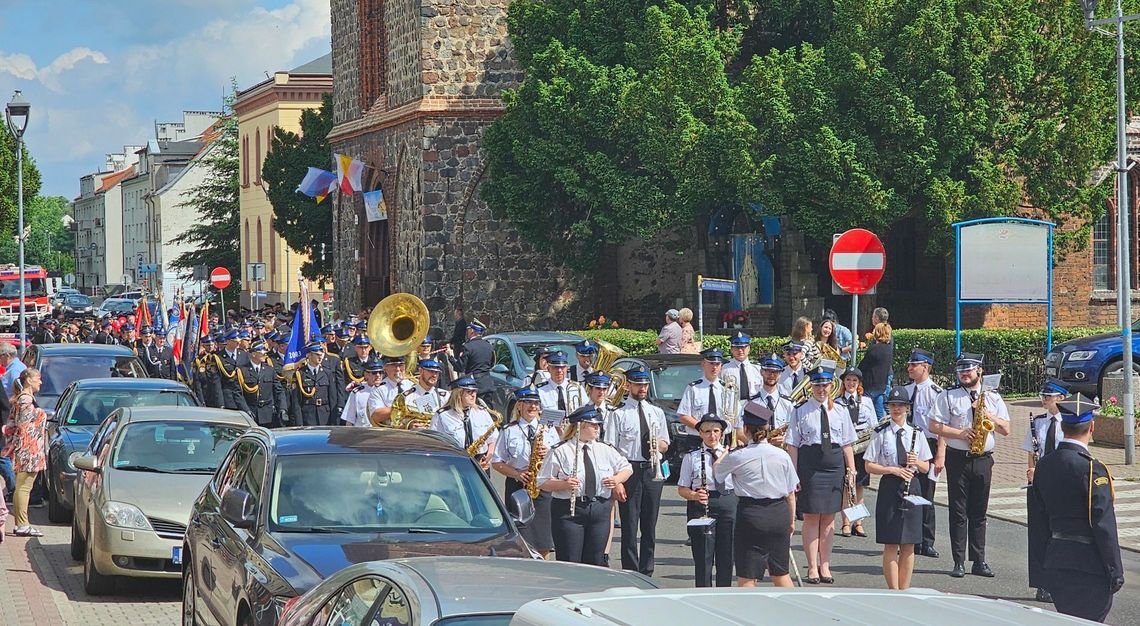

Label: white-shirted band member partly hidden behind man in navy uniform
[1021,381,1068,602]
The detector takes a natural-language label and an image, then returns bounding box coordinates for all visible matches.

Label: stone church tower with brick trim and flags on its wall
[329,0,597,330]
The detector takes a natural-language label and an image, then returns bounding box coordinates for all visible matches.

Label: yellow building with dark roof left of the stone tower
[234,54,333,307]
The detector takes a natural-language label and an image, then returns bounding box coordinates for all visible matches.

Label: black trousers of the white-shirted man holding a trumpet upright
[618,461,665,576]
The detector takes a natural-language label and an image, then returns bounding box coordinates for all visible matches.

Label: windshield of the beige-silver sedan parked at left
[111,420,245,473]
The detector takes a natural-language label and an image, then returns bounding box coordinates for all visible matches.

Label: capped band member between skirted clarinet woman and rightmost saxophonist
[906,348,946,559]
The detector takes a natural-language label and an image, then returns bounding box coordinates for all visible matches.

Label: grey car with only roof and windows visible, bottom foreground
[280,556,661,626]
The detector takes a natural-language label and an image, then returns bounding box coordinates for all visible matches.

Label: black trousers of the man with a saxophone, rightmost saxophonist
[946,448,994,563]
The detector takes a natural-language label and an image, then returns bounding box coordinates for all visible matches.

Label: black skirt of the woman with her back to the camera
[733,496,791,580]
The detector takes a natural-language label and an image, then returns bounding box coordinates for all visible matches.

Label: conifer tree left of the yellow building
[170,83,242,309]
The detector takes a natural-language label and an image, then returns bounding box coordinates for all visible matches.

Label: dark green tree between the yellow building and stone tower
[261,95,333,281]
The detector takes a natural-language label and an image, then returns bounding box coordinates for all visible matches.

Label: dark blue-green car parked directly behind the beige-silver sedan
[43,379,198,523]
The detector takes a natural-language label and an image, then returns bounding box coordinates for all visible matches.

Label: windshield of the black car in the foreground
[269,453,506,532]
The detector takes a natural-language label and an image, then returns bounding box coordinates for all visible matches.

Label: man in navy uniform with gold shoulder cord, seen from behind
[1033,393,1124,621]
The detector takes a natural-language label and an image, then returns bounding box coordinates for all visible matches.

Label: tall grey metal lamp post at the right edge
[1081,0,1140,458]
